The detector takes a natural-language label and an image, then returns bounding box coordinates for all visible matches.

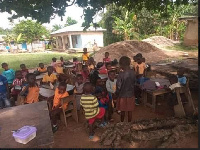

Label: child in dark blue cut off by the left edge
[0,74,10,109]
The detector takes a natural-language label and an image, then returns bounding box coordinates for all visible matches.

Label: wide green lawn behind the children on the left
[0,52,81,72]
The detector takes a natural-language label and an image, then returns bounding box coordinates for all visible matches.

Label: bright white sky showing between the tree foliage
[0,5,101,29]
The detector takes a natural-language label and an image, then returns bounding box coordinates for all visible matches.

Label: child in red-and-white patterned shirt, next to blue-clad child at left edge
[11,70,25,105]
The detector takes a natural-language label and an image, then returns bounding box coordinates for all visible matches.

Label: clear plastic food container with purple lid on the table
[13,126,37,144]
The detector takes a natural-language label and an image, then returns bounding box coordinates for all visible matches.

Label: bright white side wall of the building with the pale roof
[81,32,104,48]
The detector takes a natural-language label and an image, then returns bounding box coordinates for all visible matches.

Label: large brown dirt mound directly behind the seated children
[94,40,168,62]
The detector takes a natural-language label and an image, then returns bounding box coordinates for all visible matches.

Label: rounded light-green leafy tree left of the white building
[13,20,49,49]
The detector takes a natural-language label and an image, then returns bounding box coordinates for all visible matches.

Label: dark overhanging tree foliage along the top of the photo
[0,0,197,28]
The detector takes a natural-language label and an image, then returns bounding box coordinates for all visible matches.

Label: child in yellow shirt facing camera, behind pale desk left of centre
[42,66,57,85]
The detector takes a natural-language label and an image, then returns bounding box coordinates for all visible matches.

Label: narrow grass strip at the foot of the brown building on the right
[166,43,198,52]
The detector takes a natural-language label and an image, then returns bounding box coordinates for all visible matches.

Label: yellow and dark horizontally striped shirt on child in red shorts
[80,94,99,119]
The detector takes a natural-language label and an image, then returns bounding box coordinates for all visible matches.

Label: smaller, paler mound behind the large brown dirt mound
[142,36,177,47]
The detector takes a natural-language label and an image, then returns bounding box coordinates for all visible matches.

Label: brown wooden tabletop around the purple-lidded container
[0,101,53,148]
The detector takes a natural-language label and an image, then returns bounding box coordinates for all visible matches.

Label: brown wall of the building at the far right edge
[183,19,198,46]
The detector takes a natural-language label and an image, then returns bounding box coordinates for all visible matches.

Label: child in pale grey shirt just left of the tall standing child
[106,70,117,121]
